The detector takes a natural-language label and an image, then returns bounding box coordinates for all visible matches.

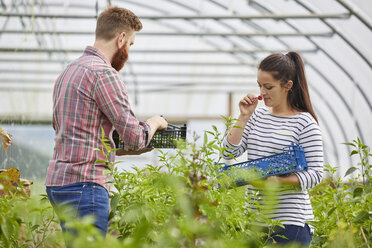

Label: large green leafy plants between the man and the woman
[96,118,279,247]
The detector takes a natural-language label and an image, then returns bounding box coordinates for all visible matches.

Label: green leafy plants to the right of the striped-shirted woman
[311,138,372,247]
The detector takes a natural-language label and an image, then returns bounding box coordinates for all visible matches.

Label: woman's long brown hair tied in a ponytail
[258,52,318,122]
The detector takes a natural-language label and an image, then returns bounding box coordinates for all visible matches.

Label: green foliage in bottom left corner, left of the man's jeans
[0,193,63,247]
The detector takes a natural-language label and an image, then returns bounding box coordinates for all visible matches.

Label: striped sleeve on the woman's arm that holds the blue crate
[295,122,323,191]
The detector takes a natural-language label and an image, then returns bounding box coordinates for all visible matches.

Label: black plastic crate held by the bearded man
[112,124,187,148]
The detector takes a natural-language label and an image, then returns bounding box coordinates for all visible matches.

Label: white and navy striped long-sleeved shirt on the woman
[224,107,323,232]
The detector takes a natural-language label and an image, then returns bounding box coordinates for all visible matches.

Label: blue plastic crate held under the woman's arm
[218,143,308,186]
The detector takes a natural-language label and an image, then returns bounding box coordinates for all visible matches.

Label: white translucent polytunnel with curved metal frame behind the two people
[0,0,372,179]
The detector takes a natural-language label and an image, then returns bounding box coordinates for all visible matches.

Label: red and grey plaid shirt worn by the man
[45,46,150,188]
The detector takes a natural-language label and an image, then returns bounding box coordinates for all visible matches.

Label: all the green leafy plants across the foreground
[0,127,372,248]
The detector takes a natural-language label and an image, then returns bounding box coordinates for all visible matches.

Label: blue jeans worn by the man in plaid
[46,182,110,236]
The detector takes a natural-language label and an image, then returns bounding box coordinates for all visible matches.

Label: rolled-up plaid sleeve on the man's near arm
[93,70,151,150]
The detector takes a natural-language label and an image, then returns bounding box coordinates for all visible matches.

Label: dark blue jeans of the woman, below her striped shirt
[271,224,313,247]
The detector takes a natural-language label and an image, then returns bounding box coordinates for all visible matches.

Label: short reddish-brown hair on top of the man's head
[96,7,142,40]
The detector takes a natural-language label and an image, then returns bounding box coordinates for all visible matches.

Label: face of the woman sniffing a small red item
[257,70,288,108]
